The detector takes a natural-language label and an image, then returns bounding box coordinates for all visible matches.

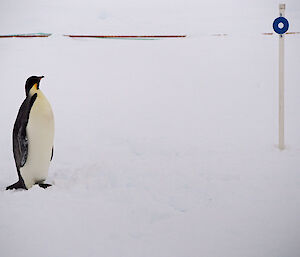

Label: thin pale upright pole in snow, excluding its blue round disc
[279,4,285,150]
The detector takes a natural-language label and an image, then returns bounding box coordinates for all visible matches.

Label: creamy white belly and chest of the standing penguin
[20,90,54,189]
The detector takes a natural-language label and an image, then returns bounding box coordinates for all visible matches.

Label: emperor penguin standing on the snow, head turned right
[6,76,54,190]
